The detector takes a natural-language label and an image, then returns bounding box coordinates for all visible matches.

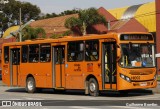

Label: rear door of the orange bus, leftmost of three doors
[10,48,20,86]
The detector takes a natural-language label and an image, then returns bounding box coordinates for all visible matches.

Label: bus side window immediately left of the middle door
[40,44,51,62]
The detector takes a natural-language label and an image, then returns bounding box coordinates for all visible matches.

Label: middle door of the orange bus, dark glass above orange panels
[53,45,65,88]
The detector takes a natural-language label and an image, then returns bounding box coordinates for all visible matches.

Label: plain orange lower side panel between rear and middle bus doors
[20,63,52,88]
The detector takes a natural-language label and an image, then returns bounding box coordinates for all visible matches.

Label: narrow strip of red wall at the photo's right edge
[155,0,160,74]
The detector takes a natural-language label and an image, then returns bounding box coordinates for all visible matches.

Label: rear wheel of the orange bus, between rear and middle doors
[26,77,36,93]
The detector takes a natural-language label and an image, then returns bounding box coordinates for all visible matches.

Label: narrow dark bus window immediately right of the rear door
[22,45,28,63]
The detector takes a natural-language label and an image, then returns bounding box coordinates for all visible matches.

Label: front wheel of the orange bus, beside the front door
[88,78,99,96]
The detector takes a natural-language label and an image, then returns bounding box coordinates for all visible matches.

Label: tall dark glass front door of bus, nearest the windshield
[102,42,117,90]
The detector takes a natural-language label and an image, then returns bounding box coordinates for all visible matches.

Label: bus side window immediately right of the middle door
[68,41,84,62]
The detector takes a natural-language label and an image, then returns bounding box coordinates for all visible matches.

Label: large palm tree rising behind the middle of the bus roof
[65,8,107,35]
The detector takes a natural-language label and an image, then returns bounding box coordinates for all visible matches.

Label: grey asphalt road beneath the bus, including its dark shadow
[0,80,160,109]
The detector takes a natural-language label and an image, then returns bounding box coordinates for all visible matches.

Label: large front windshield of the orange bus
[119,43,155,68]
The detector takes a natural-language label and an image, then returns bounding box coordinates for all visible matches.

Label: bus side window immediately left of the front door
[85,40,99,61]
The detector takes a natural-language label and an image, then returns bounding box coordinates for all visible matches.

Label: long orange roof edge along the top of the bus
[3,32,150,45]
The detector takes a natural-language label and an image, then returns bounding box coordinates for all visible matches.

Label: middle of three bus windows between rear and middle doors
[29,45,39,62]
